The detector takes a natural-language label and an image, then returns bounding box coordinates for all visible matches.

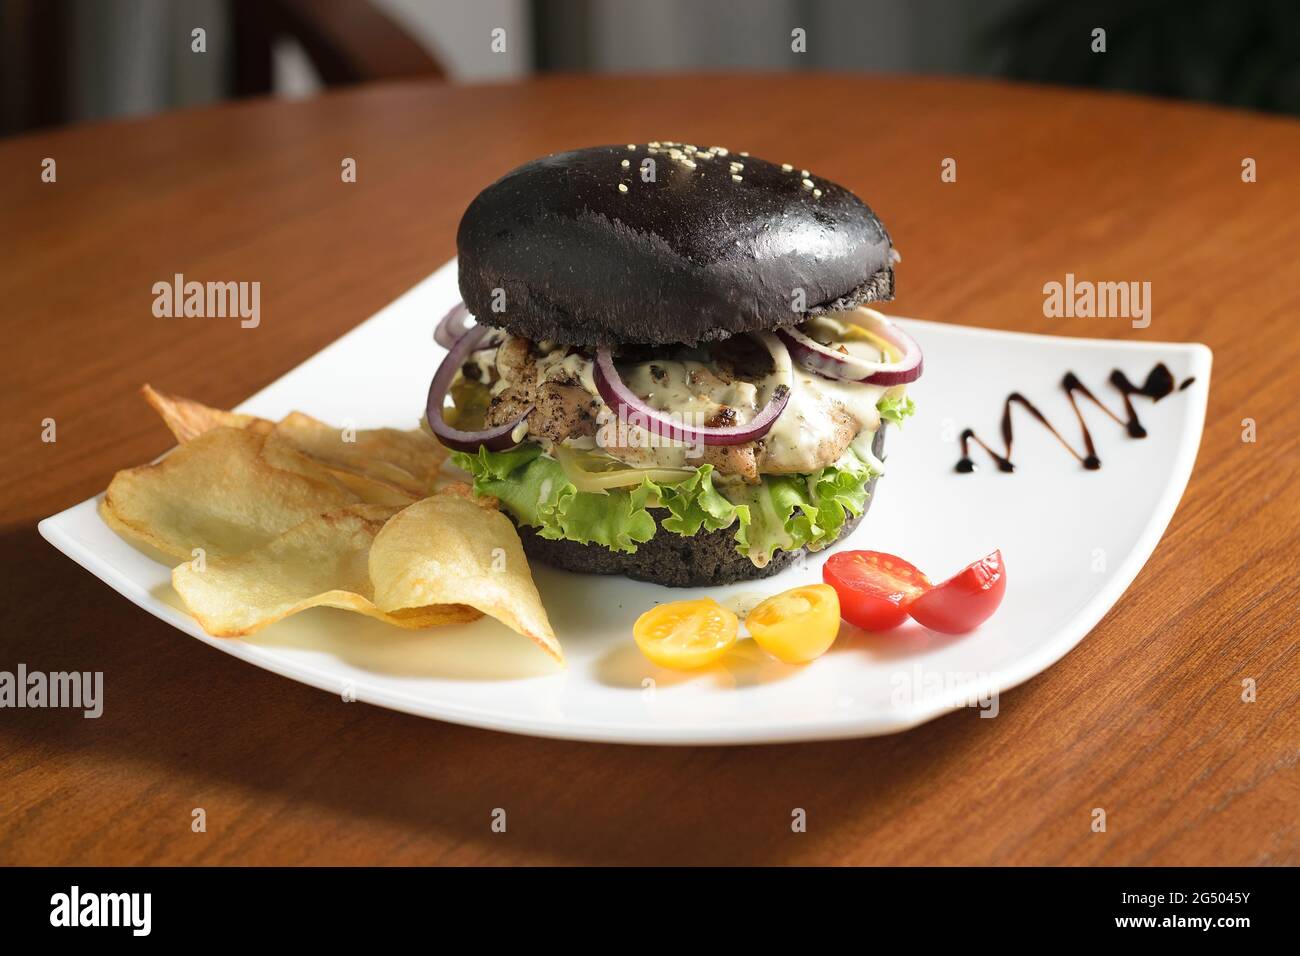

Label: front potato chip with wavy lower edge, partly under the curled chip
[172,505,482,637]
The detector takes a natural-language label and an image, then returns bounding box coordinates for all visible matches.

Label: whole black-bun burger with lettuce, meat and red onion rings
[428,140,922,587]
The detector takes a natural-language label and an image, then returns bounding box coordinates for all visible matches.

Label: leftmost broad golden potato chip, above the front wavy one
[100,425,359,559]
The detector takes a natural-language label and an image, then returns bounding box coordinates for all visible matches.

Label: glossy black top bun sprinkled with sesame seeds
[456,143,893,345]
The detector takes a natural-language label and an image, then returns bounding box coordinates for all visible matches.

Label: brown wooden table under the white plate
[0,74,1300,864]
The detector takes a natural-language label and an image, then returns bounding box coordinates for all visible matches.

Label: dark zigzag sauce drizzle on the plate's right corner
[957,362,1196,475]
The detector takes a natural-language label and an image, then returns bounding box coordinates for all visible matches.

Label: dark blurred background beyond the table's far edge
[0,0,1300,135]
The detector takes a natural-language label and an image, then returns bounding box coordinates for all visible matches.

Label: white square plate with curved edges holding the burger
[40,261,1210,744]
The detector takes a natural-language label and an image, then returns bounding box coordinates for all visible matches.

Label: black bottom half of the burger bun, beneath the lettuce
[507,428,885,588]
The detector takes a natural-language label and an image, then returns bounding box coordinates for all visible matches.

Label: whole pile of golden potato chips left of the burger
[100,385,563,661]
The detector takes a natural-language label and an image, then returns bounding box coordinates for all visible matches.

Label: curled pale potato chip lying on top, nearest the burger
[371,494,564,662]
